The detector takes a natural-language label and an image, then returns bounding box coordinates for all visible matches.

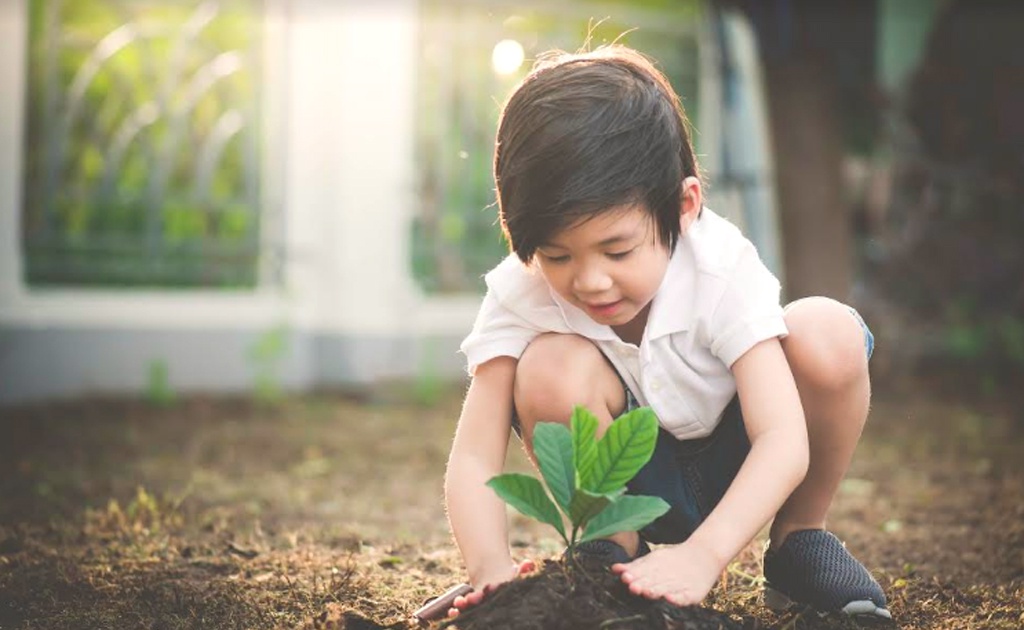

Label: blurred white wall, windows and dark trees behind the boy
[0,0,1024,411]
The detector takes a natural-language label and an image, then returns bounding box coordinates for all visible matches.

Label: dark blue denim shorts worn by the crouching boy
[512,308,874,544]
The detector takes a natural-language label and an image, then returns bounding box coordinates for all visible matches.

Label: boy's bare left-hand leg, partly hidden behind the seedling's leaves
[513,333,640,557]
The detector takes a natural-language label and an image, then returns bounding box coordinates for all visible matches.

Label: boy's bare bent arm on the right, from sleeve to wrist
[690,338,809,570]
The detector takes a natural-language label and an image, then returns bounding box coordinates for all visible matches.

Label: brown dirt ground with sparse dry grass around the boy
[0,376,1024,630]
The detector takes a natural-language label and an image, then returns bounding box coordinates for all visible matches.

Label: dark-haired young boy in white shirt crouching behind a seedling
[445,46,889,618]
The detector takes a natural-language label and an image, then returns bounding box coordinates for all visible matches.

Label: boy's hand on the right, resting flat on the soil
[611,542,723,606]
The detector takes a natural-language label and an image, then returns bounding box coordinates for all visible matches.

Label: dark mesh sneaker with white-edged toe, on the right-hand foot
[764,530,892,620]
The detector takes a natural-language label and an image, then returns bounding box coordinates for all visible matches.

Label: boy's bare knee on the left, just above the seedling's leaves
[513,333,622,426]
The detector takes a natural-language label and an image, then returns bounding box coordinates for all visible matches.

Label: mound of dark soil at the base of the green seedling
[444,557,759,630]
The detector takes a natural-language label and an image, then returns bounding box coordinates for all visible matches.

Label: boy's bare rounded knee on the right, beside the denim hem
[782,297,867,390]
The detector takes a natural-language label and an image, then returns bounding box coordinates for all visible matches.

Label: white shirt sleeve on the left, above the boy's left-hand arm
[459,290,541,375]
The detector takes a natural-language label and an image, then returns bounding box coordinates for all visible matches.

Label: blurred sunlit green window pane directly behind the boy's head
[412,0,699,293]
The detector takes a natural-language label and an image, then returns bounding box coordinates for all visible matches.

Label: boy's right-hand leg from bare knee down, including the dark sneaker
[764,298,890,619]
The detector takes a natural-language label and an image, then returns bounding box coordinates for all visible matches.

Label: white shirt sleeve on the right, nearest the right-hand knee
[709,245,788,368]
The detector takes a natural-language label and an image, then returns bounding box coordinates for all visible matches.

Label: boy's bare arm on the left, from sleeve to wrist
[444,356,517,591]
